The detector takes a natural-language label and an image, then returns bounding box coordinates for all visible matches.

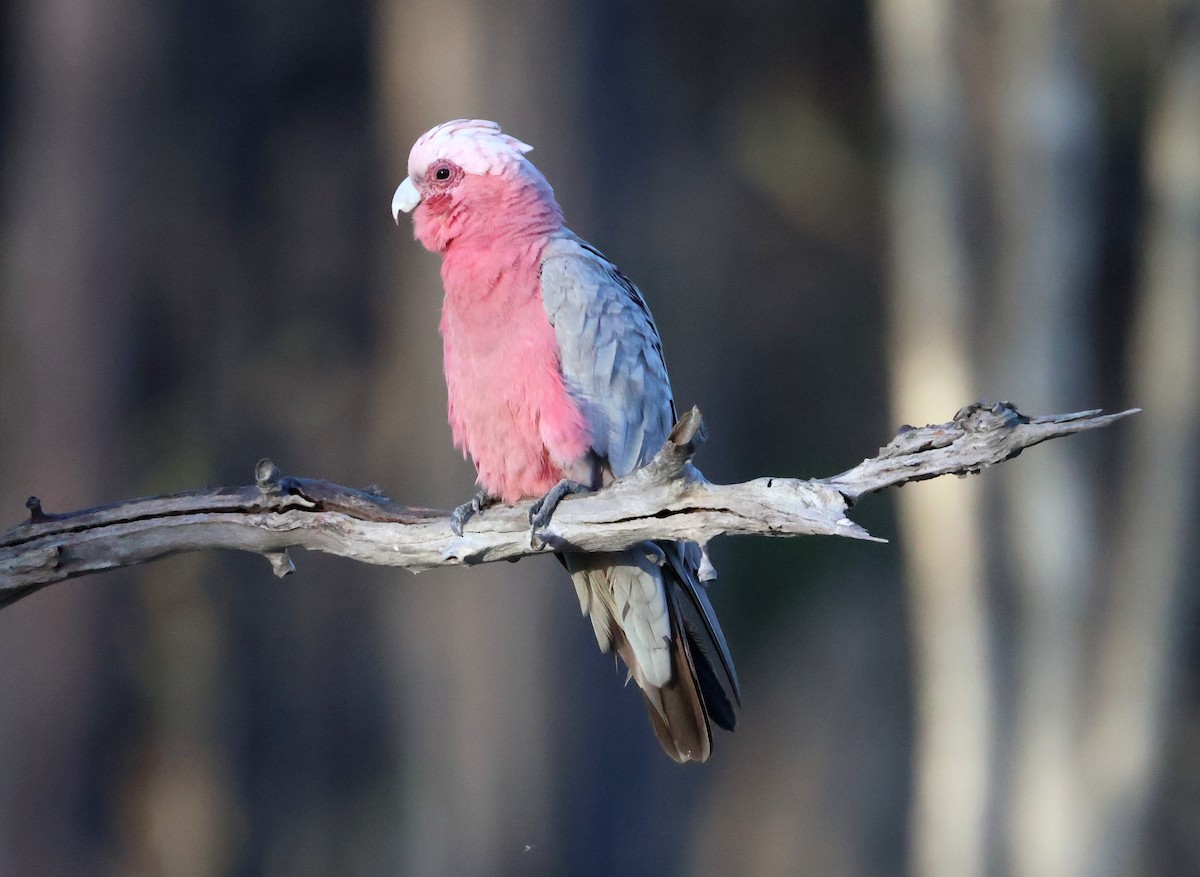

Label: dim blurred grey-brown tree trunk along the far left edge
[0,0,149,873]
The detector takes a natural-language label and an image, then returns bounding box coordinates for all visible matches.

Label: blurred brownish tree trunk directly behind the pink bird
[370,0,583,875]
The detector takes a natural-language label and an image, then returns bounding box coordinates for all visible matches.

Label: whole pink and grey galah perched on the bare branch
[391,119,740,762]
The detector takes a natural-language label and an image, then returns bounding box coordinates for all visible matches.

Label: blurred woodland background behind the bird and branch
[0,0,1200,877]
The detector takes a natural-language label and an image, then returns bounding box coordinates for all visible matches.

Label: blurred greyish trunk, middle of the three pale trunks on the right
[982,0,1098,877]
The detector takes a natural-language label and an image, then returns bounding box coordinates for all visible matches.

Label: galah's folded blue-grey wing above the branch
[541,232,674,477]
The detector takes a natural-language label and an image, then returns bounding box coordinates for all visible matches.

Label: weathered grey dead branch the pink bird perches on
[0,402,1138,606]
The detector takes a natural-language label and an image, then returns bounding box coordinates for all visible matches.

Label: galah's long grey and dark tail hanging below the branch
[563,542,742,762]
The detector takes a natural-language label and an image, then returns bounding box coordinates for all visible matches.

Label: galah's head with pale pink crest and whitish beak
[391,119,562,252]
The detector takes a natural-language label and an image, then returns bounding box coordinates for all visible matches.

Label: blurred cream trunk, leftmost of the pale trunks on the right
[876,0,994,877]
